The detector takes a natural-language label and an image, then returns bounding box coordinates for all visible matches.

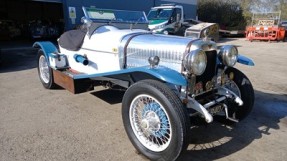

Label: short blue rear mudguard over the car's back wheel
[33,41,58,65]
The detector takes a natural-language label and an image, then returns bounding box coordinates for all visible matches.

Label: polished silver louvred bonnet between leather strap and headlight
[125,34,194,72]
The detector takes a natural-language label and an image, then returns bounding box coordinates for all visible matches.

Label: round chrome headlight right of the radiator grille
[219,45,238,67]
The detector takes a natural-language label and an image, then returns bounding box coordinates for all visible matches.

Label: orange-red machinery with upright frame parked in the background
[245,12,285,41]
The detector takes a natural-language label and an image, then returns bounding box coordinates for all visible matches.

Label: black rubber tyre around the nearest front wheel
[122,80,190,161]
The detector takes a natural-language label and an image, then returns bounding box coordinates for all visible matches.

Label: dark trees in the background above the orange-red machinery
[198,0,287,29]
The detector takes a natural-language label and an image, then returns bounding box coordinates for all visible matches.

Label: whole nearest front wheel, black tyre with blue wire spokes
[122,80,190,161]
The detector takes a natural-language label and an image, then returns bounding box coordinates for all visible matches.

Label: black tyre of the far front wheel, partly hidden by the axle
[222,68,254,124]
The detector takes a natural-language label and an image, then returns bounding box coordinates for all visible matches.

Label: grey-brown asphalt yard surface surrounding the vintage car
[0,39,287,161]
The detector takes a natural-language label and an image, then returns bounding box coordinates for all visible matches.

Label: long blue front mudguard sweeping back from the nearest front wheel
[73,66,187,86]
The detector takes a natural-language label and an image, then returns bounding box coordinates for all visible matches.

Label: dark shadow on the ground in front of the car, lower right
[179,91,287,161]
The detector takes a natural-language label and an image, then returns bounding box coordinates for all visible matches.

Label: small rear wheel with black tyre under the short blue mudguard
[37,49,57,89]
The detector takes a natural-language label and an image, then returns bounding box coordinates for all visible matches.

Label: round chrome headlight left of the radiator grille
[183,49,207,75]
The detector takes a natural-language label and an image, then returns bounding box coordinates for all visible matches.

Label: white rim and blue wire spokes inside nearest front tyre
[130,95,172,152]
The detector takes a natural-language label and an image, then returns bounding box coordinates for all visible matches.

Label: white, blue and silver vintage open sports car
[33,7,254,160]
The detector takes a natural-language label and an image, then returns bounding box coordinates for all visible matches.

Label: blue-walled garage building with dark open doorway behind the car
[0,0,197,38]
